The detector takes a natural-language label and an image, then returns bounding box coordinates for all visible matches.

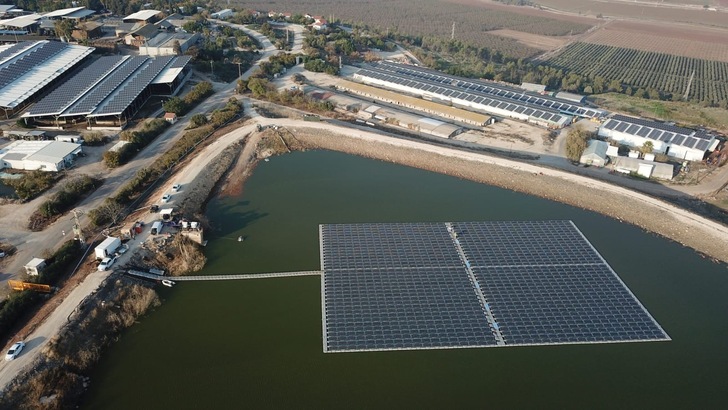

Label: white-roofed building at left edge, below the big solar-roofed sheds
[0,141,81,172]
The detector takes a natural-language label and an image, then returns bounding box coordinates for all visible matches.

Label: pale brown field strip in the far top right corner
[534,0,728,28]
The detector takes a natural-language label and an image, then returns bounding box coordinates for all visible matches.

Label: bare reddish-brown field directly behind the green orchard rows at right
[580,20,728,62]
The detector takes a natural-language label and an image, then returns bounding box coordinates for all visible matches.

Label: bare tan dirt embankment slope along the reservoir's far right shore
[278,128,728,262]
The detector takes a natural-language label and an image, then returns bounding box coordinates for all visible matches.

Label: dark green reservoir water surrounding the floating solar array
[85,151,728,409]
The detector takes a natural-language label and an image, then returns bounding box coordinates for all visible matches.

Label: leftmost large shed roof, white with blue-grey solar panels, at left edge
[0,40,94,108]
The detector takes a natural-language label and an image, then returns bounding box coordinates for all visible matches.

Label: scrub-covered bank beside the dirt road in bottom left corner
[0,275,160,409]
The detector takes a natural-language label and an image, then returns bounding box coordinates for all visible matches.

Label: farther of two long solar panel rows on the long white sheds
[377,61,603,117]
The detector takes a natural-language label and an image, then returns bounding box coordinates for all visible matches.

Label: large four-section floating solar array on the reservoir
[319,221,669,352]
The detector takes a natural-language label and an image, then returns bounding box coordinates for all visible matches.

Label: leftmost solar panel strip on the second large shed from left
[29,56,125,116]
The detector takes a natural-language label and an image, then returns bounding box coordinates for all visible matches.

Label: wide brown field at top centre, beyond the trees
[231,0,596,58]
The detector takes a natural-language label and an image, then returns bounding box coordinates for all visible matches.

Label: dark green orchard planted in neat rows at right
[548,42,728,104]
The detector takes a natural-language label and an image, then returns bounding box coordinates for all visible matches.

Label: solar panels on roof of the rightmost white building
[602,114,713,151]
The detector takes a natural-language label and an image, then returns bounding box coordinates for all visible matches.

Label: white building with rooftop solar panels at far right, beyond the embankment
[598,115,718,161]
